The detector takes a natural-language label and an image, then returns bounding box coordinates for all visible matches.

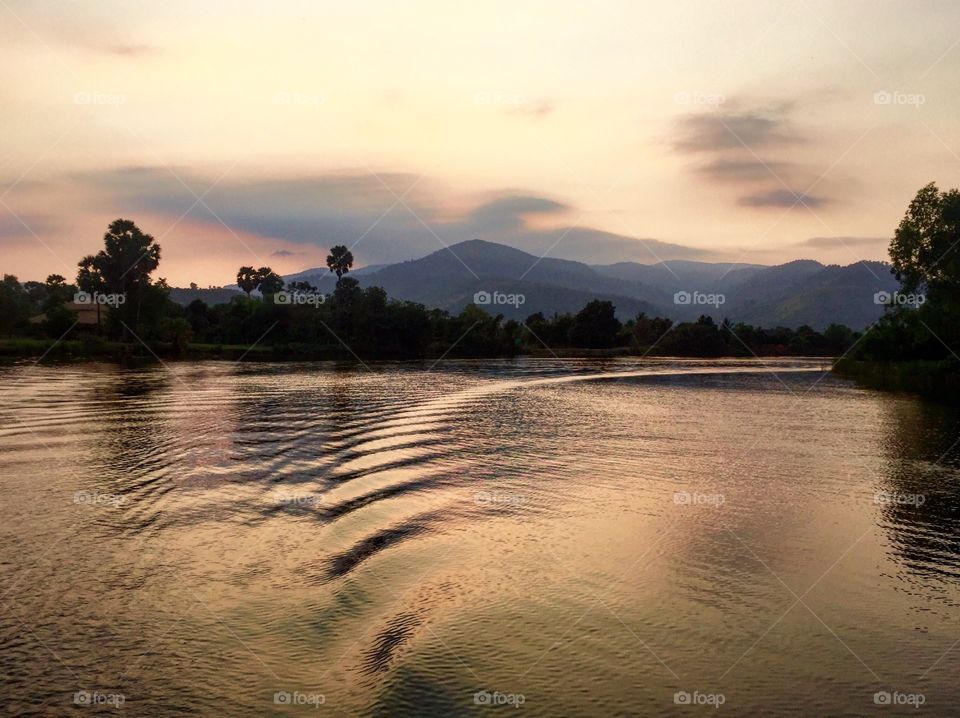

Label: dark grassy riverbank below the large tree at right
[833,359,960,404]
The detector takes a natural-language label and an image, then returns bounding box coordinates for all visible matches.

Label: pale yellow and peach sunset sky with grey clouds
[0,0,960,286]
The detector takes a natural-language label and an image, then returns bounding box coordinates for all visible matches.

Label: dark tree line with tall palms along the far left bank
[0,219,872,360]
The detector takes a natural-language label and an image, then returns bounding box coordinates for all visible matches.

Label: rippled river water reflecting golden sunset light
[0,360,960,716]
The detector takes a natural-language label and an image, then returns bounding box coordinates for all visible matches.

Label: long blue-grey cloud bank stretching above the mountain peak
[74,167,712,264]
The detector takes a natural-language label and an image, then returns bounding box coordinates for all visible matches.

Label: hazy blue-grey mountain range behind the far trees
[173,239,899,330]
